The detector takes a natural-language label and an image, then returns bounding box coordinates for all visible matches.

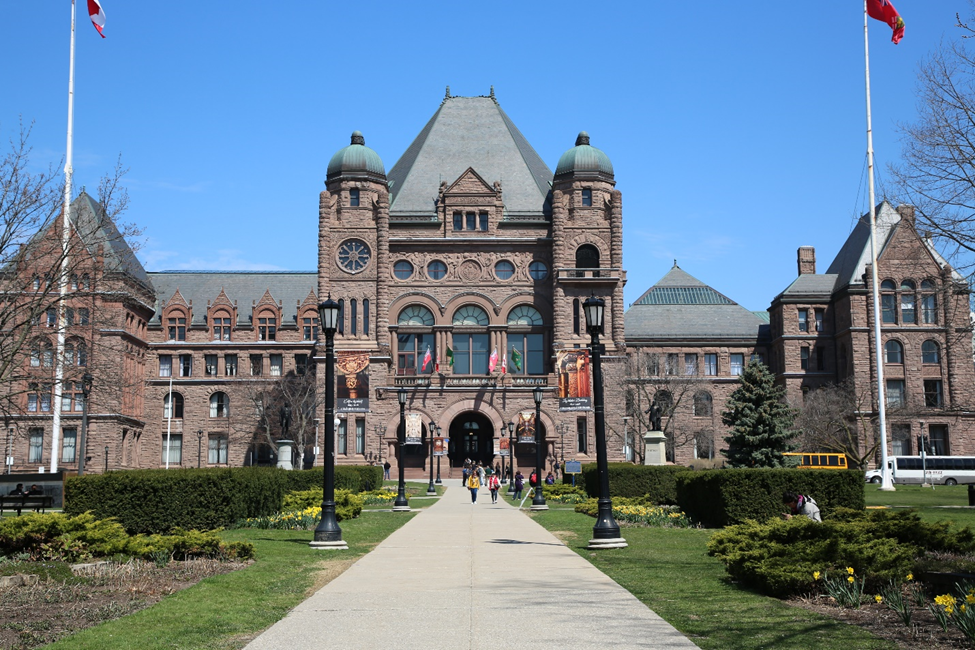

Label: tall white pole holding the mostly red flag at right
[863,0,895,490]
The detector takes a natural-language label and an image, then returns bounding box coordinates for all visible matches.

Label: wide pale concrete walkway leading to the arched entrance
[246,479,697,650]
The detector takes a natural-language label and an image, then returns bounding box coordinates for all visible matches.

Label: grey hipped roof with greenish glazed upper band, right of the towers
[625,265,769,341]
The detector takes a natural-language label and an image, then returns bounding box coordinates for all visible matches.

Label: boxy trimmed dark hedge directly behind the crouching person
[676,469,865,528]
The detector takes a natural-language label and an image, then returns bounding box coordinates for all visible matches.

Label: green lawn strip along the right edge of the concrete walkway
[531,508,897,650]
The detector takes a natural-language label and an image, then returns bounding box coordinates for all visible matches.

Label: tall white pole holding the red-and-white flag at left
[51,0,79,473]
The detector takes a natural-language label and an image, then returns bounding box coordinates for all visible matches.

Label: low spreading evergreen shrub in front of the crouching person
[708,510,975,597]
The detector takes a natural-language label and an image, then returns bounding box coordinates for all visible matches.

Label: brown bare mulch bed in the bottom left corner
[0,559,248,650]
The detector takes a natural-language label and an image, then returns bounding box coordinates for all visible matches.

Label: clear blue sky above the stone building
[0,0,969,310]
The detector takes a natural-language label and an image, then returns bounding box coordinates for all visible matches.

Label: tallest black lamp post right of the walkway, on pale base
[582,296,627,549]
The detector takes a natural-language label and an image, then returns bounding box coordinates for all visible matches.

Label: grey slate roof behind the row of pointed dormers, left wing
[149,271,318,326]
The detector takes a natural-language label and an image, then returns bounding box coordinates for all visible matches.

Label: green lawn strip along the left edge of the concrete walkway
[46,512,413,650]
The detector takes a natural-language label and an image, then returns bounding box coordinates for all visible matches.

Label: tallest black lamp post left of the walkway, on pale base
[311,296,349,549]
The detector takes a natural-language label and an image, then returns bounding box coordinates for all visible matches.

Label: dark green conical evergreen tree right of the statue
[721,361,796,467]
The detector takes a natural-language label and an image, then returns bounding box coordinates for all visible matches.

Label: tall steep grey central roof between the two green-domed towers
[387,97,553,217]
